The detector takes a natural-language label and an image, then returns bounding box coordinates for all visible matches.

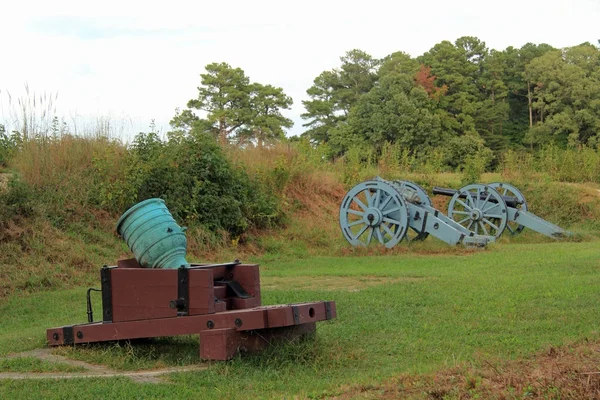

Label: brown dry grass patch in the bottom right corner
[336,341,600,399]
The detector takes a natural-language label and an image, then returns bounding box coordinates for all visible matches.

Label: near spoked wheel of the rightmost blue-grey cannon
[448,184,508,237]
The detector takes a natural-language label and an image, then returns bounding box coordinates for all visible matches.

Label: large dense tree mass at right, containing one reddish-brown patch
[302,36,600,169]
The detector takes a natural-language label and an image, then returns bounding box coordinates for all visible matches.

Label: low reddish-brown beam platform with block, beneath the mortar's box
[46,301,336,360]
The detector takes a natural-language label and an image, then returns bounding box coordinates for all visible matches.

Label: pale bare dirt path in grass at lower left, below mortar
[0,349,207,383]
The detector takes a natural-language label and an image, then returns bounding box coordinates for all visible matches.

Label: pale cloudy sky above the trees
[0,0,600,138]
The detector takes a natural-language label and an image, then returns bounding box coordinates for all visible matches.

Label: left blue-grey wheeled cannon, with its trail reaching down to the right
[339,177,494,248]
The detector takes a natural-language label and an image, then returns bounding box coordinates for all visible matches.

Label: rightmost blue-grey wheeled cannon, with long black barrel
[433,182,571,239]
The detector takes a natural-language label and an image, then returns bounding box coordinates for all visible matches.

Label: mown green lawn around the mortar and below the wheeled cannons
[0,241,600,399]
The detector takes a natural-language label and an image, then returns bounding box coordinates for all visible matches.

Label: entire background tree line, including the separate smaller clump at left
[171,36,600,165]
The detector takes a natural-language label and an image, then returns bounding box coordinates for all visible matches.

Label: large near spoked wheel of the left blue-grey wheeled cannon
[340,181,408,248]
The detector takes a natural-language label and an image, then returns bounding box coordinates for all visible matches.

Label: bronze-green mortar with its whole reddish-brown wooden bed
[46,199,336,360]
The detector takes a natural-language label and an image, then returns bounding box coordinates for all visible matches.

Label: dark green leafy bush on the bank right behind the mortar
[121,131,281,237]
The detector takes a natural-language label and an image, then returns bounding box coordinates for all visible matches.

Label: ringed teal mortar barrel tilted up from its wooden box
[117,199,189,268]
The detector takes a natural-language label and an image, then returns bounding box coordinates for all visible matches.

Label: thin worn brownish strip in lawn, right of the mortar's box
[261,276,425,292]
